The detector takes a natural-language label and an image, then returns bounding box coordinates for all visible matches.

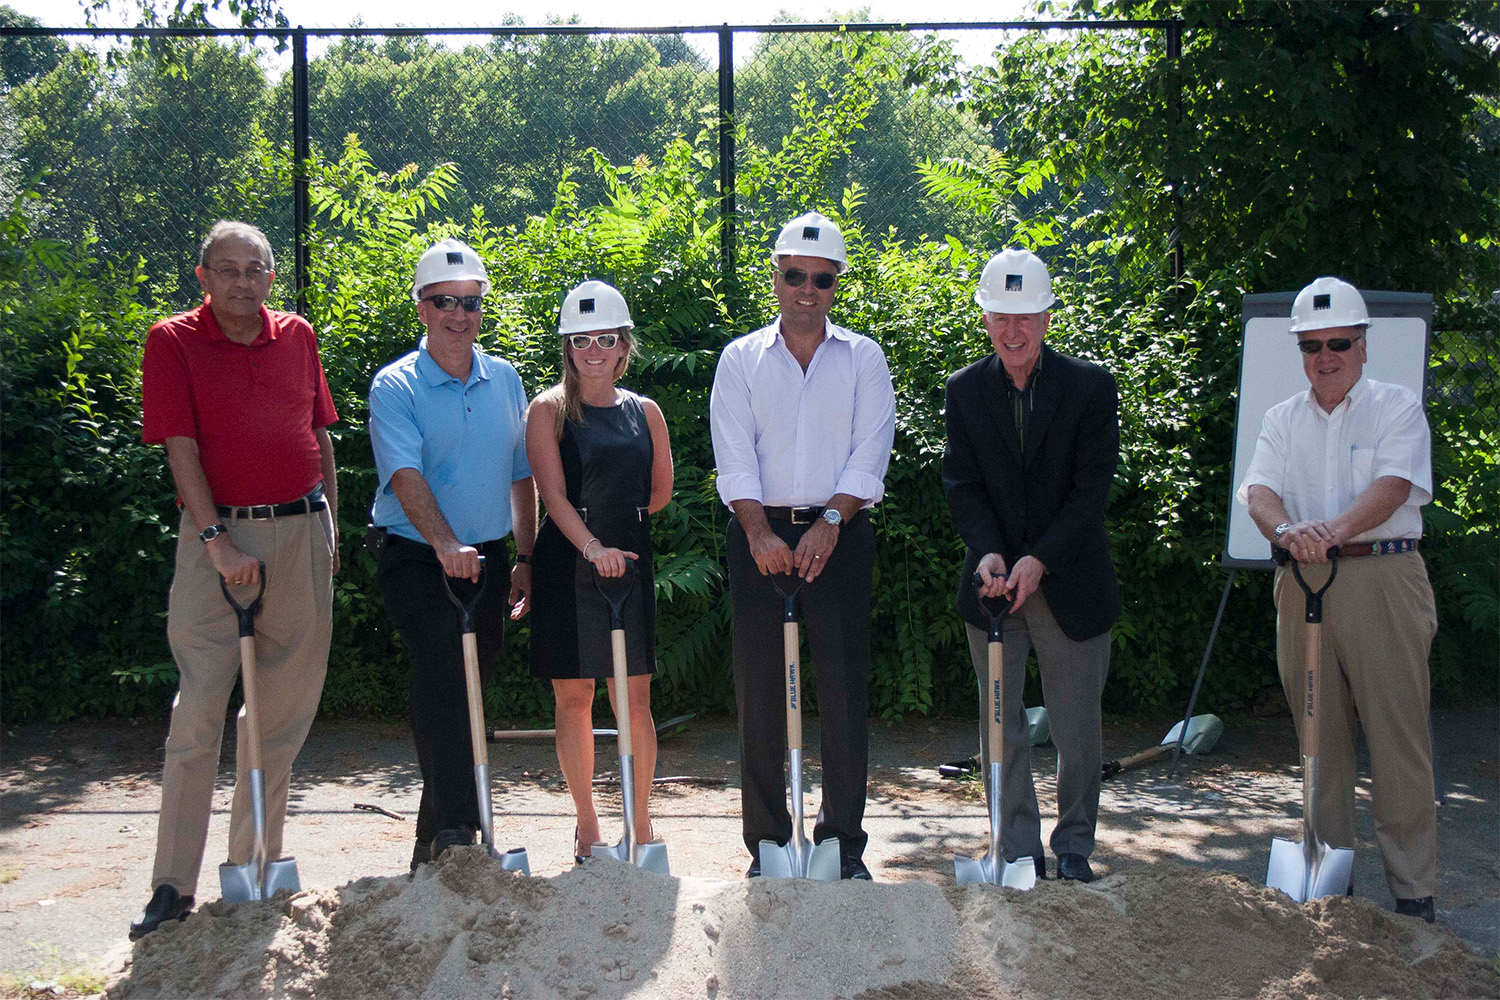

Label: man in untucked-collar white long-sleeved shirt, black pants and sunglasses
[710,211,896,879]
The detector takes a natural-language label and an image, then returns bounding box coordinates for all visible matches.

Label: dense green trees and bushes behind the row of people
[0,9,1500,720]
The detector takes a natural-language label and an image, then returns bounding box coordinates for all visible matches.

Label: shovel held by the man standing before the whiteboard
[1266,547,1355,903]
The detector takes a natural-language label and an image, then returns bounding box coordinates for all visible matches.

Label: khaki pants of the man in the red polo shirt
[152,510,333,895]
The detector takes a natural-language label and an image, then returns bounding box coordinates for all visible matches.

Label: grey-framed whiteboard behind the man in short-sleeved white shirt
[1220,289,1433,570]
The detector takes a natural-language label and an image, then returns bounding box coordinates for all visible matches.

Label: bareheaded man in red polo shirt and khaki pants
[131,222,339,939]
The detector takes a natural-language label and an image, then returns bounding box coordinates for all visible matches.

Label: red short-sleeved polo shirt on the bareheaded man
[141,297,339,507]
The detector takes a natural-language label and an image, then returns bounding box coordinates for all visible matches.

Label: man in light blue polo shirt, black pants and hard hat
[371,240,537,870]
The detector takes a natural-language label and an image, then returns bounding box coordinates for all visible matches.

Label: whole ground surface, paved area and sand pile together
[0,708,1500,1000]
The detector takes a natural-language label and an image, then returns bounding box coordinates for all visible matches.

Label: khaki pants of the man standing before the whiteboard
[1275,552,1437,900]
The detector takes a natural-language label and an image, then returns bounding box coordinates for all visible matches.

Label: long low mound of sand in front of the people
[108,847,1500,1000]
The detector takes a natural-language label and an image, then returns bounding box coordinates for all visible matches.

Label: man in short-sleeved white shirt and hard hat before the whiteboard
[1238,277,1437,924]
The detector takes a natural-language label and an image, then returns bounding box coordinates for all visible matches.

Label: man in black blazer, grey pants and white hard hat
[942,250,1121,882]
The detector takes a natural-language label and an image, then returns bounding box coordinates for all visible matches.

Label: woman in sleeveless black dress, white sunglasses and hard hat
[527,282,672,861]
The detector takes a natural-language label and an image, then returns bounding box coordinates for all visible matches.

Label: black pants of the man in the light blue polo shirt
[378,535,510,841]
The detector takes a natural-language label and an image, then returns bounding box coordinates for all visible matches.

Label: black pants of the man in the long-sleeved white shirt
[726,511,875,858]
